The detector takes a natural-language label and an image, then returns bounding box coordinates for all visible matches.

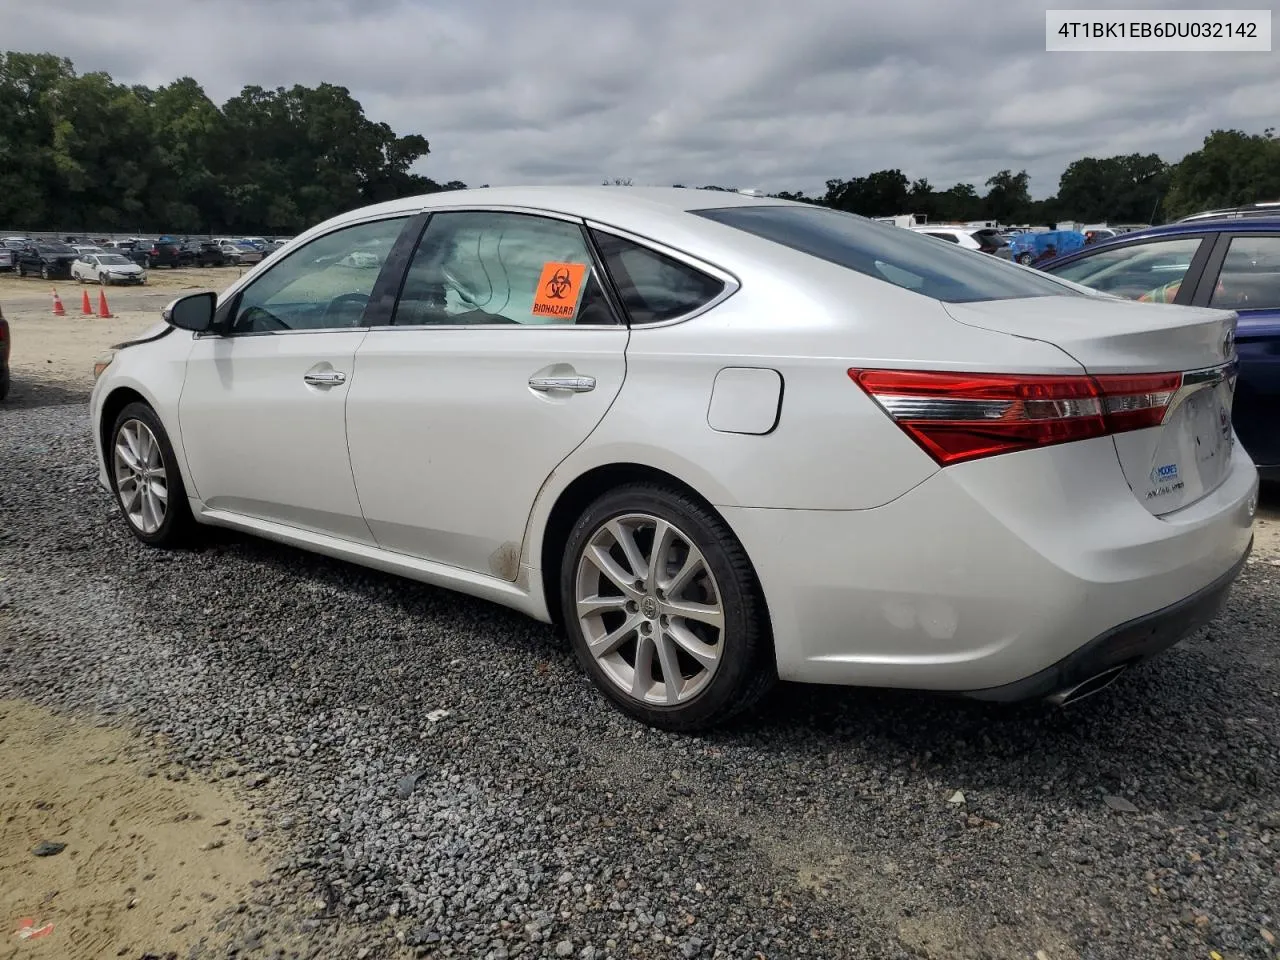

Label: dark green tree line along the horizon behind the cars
[0,52,1280,236]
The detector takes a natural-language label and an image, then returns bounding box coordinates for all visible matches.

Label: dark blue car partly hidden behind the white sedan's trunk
[1037,216,1280,480]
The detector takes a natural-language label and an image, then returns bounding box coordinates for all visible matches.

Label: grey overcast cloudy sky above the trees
[0,0,1280,197]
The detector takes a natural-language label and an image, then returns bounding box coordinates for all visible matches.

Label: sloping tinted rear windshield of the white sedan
[691,205,1084,303]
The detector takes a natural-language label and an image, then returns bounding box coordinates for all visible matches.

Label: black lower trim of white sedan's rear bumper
[965,540,1253,703]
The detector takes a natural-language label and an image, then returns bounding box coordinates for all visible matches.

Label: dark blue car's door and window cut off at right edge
[1192,230,1280,475]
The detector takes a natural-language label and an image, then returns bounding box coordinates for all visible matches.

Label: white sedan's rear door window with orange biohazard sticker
[393,210,618,326]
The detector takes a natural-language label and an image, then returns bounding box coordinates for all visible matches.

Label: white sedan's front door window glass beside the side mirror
[228,216,408,335]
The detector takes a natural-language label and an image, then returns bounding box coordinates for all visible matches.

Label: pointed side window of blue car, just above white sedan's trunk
[1050,237,1204,303]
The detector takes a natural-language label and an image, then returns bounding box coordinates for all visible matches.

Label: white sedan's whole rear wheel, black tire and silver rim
[561,483,777,731]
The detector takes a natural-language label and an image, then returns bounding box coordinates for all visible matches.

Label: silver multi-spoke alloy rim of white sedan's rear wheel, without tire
[575,513,724,705]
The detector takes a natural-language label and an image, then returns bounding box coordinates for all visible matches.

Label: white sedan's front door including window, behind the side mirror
[179,215,410,543]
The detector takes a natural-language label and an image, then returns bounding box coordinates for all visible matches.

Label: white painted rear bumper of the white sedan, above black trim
[721,438,1258,695]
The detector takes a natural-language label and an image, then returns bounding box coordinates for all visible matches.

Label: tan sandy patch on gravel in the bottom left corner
[0,700,268,960]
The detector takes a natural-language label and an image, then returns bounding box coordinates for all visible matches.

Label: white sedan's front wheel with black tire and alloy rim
[105,403,195,547]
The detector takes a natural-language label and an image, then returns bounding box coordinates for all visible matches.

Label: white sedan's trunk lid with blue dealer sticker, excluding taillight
[945,297,1238,516]
